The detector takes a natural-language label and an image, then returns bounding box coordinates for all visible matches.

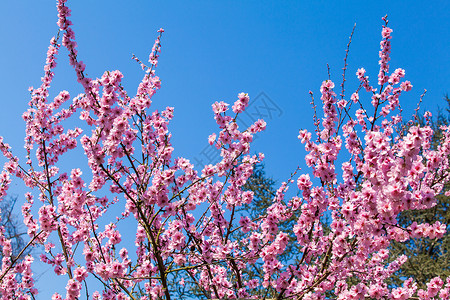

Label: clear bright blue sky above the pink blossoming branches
[0,0,450,299]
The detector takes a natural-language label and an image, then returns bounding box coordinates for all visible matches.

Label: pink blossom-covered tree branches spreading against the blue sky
[0,0,450,300]
